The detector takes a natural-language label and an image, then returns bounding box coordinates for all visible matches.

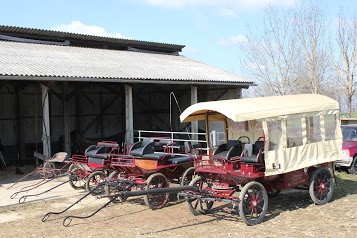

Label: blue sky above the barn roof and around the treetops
[0,0,357,80]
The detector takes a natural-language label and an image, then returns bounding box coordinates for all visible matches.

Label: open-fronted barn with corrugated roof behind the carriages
[0,26,254,164]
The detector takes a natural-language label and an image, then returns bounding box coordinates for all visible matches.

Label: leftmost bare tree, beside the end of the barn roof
[241,7,297,96]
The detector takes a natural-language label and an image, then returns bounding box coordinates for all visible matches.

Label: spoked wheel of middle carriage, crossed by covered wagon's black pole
[144,173,169,209]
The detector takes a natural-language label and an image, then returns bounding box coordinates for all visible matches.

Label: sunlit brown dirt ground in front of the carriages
[0,172,357,238]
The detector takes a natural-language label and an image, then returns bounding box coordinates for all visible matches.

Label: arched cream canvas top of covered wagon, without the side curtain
[180,94,339,122]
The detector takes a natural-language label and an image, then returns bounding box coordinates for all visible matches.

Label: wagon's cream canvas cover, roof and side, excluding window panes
[180,94,342,176]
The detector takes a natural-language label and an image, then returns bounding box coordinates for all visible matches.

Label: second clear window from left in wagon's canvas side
[286,118,302,148]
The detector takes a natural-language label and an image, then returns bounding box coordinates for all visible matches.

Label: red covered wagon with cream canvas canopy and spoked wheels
[180,94,342,225]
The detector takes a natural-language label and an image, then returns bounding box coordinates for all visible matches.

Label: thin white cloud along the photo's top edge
[136,0,295,10]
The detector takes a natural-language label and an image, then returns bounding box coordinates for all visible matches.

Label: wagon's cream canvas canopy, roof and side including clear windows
[180,94,342,176]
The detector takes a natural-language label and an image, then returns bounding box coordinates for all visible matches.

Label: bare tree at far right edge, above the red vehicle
[334,10,357,117]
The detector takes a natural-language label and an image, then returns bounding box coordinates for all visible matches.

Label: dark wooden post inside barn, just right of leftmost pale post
[62,82,71,156]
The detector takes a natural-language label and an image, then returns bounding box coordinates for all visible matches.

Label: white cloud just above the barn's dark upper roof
[51,21,130,39]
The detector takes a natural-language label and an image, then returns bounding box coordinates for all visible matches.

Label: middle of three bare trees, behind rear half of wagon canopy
[293,1,331,94]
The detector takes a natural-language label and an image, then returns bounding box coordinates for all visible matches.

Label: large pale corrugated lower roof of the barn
[0,41,253,86]
